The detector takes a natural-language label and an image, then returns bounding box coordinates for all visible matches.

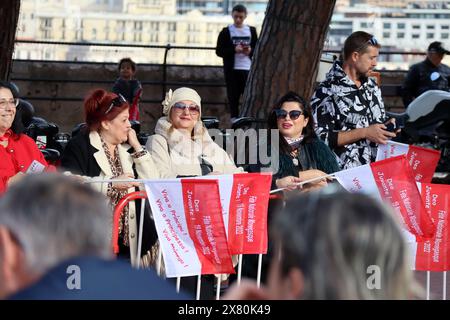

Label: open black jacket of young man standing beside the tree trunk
[216,26,258,79]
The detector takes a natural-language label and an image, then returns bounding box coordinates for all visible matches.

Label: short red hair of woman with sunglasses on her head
[84,89,130,131]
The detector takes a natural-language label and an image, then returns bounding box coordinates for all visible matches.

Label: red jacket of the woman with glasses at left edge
[0,134,54,194]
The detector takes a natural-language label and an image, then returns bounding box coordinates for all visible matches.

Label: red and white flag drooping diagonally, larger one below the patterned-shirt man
[335,155,436,238]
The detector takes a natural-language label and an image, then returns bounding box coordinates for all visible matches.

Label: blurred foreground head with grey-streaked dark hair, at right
[225,187,414,300]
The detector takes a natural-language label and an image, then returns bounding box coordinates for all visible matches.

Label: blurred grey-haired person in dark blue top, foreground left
[0,174,186,299]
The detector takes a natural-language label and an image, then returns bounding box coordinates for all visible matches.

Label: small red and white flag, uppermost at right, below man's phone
[376,141,441,183]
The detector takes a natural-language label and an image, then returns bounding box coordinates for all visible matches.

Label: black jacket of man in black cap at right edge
[402,58,450,107]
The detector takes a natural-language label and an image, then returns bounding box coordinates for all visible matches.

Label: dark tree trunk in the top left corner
[0,0,20,80]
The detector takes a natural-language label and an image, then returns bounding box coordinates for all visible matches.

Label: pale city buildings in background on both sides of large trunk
[14,0,450,69]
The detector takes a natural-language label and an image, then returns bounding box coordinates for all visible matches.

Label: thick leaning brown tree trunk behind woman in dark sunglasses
[241,0,336,119]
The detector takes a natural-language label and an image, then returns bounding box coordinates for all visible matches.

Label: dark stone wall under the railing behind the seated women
[11,60,404,133]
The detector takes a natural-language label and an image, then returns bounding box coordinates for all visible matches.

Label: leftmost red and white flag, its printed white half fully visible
[145,179,235,278]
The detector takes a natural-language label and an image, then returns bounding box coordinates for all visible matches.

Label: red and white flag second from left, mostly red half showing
[196,173,272,254]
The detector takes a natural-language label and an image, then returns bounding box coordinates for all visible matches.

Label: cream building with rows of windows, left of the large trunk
[14,0,264,65]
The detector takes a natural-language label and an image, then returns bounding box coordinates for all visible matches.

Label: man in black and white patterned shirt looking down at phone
[311,31,396,169]
